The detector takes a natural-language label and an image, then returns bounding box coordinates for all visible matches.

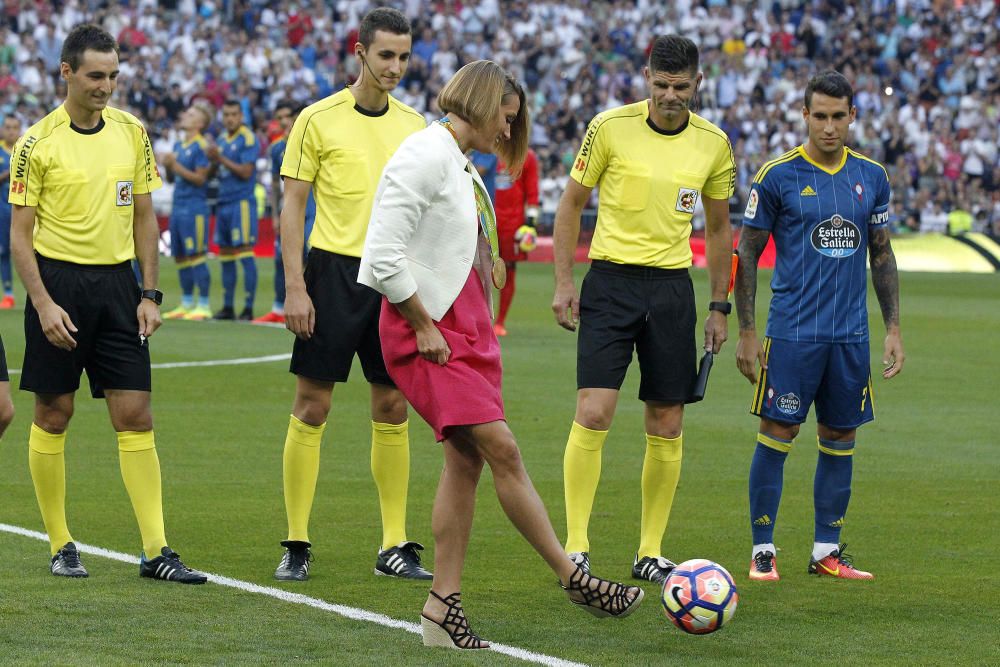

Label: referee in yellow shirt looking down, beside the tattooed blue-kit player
[552,35,736,583]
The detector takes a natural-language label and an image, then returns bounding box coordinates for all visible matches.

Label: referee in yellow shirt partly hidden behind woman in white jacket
[274,7,431,581]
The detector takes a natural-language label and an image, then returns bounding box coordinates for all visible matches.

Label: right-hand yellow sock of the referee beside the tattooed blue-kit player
[639,433,684,558]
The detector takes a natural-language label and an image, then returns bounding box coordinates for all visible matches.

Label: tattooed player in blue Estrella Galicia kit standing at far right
[735,71,905,581]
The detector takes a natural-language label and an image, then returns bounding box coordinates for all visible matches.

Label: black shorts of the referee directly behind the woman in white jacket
[289,248,396,387]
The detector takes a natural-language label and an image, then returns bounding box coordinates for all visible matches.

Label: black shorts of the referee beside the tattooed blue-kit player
[576,260,697,403]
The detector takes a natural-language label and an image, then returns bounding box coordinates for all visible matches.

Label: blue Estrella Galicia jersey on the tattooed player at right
[743,146,890,343]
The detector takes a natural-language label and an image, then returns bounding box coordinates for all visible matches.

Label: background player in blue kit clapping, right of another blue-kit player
[208,100,260,321]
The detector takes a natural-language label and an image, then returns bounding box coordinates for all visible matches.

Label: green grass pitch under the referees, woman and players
[0,260,1000,665]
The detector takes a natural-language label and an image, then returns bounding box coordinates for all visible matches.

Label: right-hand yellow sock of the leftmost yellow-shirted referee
[118,431,167,558]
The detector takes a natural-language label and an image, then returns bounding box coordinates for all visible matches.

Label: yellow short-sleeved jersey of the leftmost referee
[8,105,162,264]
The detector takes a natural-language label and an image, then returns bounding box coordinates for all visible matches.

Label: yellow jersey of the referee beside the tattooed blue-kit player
[570,100,736,269]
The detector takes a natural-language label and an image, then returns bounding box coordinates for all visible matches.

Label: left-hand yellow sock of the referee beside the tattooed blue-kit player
[563,421,608,553]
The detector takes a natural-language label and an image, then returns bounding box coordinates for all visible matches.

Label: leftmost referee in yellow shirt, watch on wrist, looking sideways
[9,25,207,584]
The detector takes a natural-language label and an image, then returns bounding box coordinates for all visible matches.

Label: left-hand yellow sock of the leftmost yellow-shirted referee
[28,424,73,556]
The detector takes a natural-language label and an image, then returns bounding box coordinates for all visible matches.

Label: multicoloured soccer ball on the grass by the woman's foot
[661,558,739,635]
